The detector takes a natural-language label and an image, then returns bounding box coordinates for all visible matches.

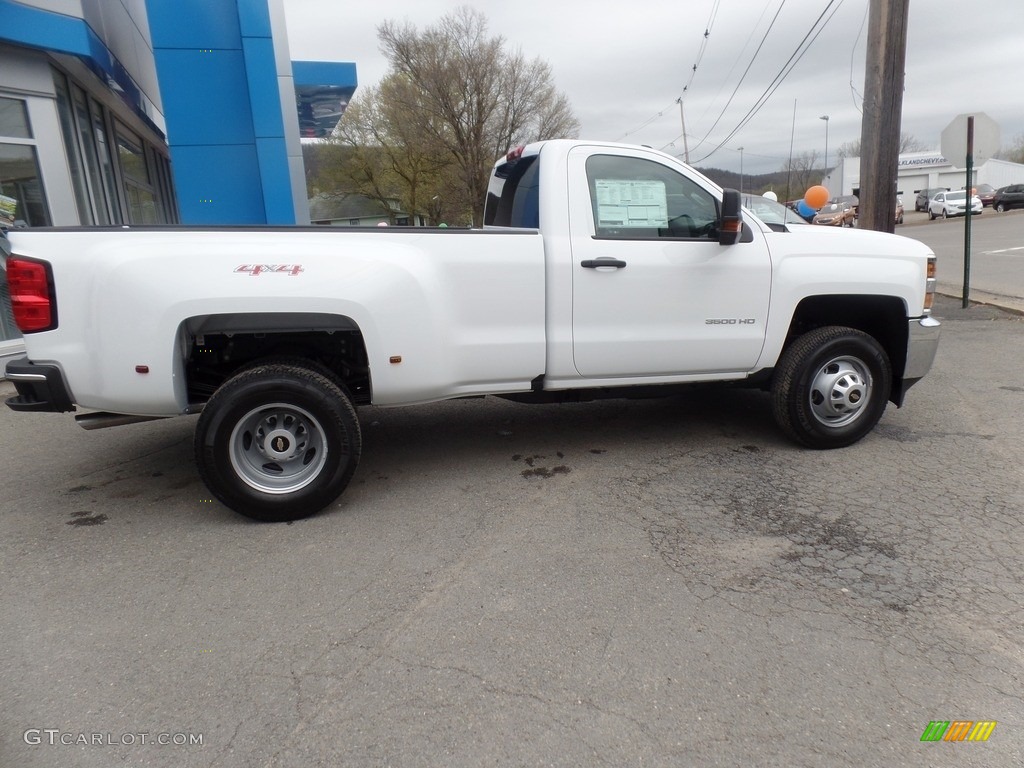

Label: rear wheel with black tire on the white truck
[195,364,362,522]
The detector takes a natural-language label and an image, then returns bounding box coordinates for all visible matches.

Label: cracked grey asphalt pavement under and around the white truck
[0,290,1024,768]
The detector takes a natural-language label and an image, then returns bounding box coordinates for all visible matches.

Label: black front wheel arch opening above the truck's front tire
[780,294,909,407]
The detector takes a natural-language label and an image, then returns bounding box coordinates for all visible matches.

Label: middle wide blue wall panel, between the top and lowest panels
[155,48,256,147]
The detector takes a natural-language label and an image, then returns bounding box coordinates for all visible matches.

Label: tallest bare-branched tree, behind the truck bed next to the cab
[380,6,580,225]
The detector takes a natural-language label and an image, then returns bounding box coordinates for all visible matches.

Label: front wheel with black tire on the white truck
[772,326,892,449]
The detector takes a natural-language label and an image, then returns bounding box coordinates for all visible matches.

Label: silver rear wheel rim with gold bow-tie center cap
[228,402,328,495]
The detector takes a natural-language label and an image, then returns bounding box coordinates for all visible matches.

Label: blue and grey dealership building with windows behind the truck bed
[0,0,356,370]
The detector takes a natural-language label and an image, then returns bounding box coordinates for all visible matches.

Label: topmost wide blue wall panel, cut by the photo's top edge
[145,0,241,50]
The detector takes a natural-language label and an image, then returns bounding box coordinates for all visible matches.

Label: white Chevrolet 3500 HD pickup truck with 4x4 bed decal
[0,140,939,521]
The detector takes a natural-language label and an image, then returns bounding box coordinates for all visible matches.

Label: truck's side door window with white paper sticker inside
[587,155,718,240]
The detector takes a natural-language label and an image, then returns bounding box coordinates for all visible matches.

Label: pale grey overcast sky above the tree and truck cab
[285,0,1024,173]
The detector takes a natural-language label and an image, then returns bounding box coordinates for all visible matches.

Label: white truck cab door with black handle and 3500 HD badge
[568,146,771,379]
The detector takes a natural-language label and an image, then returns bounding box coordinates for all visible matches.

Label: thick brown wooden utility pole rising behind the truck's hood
[858,0,910,232]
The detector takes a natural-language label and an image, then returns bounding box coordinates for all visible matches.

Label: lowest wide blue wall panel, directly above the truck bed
[171,144,264,224]
